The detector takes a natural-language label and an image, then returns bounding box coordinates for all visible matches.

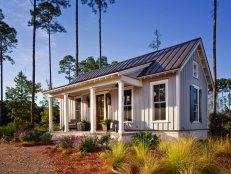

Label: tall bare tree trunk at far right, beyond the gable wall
[213,0,217,114]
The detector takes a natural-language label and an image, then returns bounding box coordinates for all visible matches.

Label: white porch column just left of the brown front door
[90,88,96,133]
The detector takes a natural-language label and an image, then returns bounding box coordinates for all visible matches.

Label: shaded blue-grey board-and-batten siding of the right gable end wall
[180,52,208,130]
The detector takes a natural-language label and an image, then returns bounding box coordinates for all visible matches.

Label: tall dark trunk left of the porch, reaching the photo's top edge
[31,0,37,129]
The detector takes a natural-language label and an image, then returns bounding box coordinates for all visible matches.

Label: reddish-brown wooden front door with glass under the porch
[96,94,105,130]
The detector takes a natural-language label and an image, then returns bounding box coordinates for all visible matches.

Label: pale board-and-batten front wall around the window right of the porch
[132,75,177,130]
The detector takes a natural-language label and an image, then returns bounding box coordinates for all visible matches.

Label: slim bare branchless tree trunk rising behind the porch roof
[75,0,79,77]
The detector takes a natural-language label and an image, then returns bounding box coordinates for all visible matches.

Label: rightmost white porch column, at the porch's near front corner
[118,81,124,134]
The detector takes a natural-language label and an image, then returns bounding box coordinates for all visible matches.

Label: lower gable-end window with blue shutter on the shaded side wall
[190,85,201,122]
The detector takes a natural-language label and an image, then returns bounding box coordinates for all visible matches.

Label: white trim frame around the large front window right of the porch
[150,79,169,123]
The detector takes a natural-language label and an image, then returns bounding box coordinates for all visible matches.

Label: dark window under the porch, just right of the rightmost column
[124,89,132,121]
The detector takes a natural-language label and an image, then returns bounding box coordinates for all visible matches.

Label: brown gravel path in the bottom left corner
[0,143,52,174]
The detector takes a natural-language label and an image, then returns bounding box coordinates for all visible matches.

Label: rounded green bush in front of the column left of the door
[78,136,98,152]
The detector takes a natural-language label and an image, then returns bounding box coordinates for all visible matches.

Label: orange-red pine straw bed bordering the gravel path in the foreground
[43,146,112,174]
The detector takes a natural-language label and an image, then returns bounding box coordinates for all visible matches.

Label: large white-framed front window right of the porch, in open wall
[151,80,168,121]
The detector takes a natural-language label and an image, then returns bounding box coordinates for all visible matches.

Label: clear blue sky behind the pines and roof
[0,0,231,100]
